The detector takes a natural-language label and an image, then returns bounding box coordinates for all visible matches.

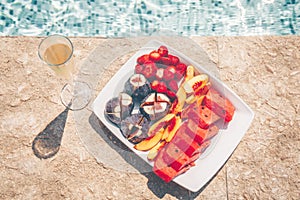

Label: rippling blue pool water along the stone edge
[0,0,300,37]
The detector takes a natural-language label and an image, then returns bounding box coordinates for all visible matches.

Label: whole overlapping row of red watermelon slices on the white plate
[153,89,235,182]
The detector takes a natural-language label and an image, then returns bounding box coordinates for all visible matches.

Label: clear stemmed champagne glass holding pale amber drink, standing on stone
[38,35,92,110]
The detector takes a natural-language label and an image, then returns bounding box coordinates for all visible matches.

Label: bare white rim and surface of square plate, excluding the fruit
[93,40,254,192]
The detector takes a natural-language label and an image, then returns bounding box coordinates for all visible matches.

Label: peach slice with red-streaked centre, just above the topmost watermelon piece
[183,74,208,94]
